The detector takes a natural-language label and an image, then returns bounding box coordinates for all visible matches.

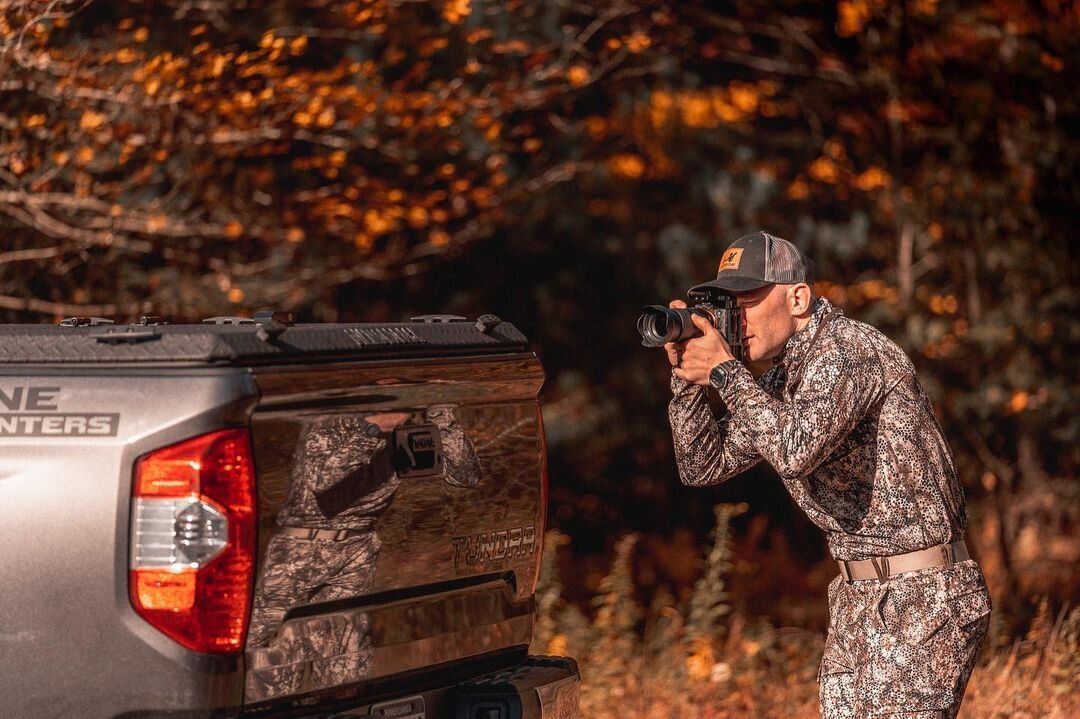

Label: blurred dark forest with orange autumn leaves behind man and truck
[0,0,1080,716]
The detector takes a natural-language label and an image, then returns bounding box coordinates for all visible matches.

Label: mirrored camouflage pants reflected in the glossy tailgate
[244,532,380,702]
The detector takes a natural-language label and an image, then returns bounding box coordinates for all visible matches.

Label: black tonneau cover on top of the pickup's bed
[0,315,527,365]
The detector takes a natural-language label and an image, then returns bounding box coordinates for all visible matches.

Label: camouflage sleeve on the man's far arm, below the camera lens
[667,372,761,487]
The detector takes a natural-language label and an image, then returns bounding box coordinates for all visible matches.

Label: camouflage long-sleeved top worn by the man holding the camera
[669,299,967,559]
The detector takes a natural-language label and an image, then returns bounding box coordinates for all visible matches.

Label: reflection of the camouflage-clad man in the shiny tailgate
[246,406,480,701]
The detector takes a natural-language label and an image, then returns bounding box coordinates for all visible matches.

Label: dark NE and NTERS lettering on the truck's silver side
[0,385,120,437]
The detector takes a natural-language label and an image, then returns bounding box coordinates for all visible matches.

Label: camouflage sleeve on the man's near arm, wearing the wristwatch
[723,347,887,479]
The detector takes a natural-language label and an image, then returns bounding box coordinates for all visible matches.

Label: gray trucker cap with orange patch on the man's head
[690,232,813,293]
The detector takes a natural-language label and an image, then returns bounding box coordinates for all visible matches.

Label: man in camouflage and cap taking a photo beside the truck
[665,232,990,719]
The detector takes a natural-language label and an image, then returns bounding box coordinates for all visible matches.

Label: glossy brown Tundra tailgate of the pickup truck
[244,353,546,705]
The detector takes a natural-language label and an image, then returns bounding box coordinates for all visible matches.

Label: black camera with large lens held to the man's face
[637,288,746,362]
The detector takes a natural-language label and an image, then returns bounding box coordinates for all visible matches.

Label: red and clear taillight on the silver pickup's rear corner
[130,430,256,654]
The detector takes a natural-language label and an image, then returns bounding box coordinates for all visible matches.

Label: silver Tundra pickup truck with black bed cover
[0,312,579,719]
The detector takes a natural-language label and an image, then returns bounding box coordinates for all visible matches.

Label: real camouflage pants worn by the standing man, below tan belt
[818,559,990,719]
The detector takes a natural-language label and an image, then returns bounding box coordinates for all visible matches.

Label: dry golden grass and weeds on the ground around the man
[532,505,1080,719]
